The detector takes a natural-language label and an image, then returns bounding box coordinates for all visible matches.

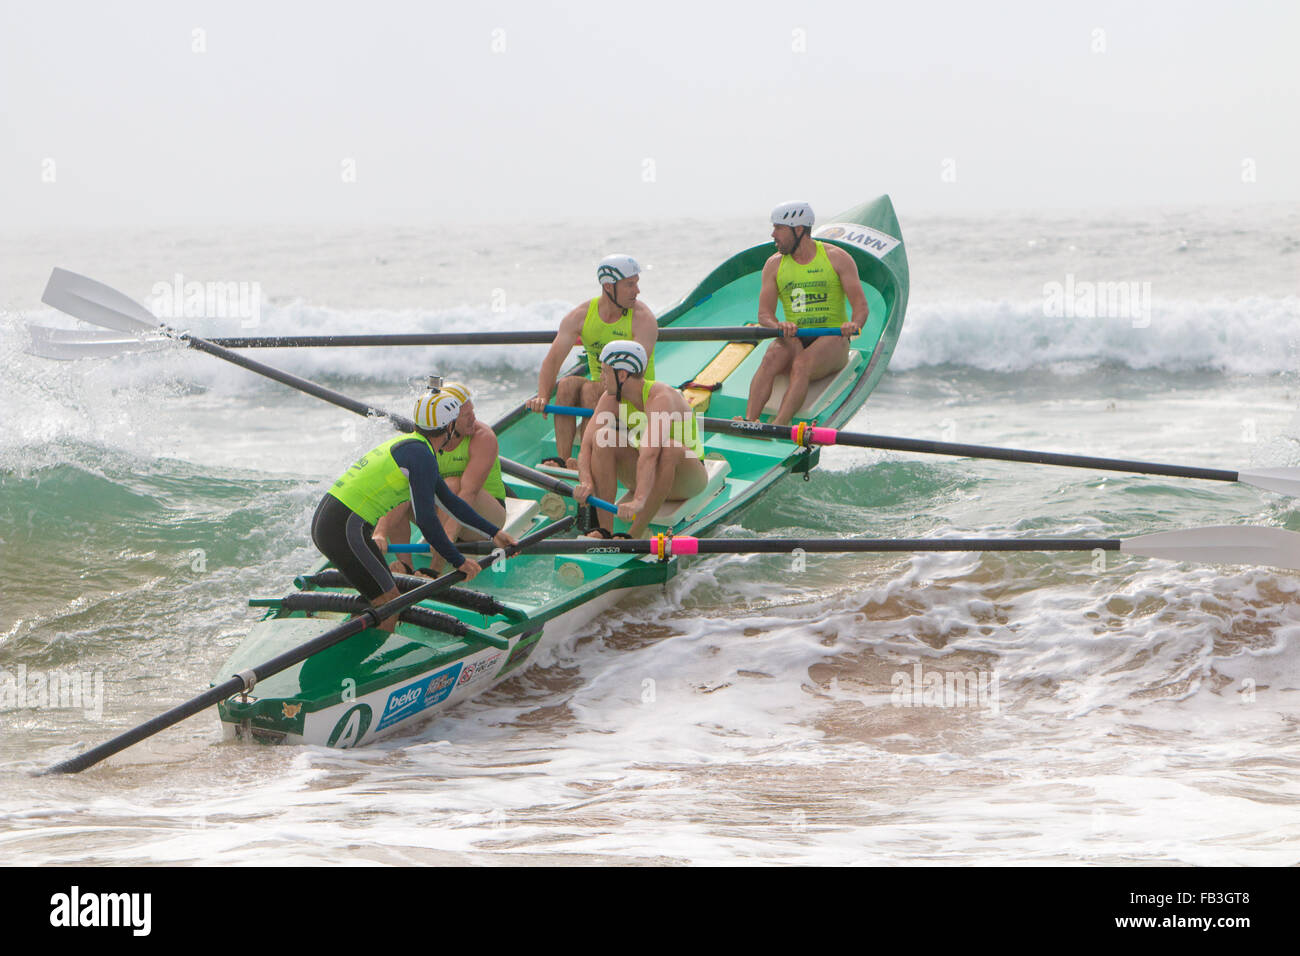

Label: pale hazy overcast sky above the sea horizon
[0,0,1300,232]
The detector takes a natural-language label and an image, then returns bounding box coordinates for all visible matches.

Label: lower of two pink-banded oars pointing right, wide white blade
[431,524,1300,568]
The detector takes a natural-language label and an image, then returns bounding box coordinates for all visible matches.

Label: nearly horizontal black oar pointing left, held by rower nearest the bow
[27,324,840,360]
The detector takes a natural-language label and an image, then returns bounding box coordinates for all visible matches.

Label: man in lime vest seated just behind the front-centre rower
[528,255,659,468]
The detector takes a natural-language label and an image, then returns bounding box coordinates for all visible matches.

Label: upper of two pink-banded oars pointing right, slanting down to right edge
[546,405,1300,496]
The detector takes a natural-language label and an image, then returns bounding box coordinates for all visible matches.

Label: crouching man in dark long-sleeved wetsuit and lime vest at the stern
[312,390,517,633]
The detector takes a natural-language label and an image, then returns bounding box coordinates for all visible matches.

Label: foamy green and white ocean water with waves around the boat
[0,207,1300,865]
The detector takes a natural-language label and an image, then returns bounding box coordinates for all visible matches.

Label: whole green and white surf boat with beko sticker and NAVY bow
[217,196,909,747]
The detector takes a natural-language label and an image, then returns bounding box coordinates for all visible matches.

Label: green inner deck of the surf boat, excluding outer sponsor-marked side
[218,196,907,732]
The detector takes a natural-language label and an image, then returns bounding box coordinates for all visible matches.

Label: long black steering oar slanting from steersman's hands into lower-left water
[42,515,573,774]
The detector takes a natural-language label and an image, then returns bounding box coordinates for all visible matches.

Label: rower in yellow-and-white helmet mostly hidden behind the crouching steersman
[373,377,506,578]
